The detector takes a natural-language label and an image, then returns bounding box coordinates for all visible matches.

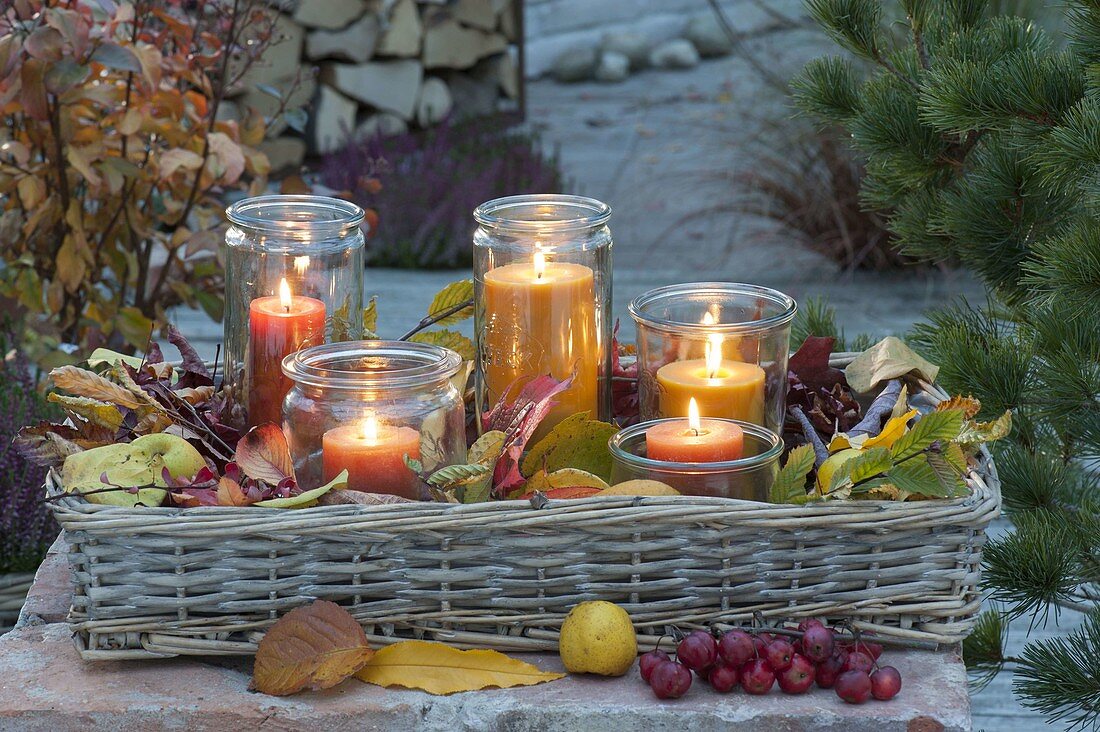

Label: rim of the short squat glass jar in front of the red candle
[283,340,462,390]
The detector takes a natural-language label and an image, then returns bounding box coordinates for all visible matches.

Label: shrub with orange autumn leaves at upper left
[0,0,279,367]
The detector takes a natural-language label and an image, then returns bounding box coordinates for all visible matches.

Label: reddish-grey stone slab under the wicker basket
[0,623,970,732]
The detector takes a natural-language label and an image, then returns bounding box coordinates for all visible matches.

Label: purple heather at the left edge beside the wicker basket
[0,339,58,575]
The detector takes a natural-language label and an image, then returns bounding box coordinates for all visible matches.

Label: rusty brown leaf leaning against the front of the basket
[251,600,374,697]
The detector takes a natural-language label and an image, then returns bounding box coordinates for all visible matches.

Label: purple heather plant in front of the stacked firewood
[321,118,562,269]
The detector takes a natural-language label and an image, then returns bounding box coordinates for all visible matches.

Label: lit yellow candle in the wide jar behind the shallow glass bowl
[657,335,766,425]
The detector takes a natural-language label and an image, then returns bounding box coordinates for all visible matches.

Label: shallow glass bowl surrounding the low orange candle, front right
[608,419,783,502]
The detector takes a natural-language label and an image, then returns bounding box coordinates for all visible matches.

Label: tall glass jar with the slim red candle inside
[224,196,363,425]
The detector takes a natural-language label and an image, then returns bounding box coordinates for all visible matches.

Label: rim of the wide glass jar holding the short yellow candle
[627,282,799,337]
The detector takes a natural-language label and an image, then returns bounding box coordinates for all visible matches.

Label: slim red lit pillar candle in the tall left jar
[249,280,326,426]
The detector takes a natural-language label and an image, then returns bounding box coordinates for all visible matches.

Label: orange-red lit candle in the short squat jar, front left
[321,415,420,501]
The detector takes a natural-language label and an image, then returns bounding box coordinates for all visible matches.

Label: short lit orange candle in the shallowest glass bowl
[646,400,745,462]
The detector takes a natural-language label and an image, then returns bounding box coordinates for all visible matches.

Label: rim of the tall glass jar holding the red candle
[226,194,366,245]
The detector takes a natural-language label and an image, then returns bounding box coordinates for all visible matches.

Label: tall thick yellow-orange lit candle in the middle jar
[482,252,600,439]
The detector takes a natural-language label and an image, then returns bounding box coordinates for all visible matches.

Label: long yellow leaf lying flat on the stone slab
[355,641,565,695]
